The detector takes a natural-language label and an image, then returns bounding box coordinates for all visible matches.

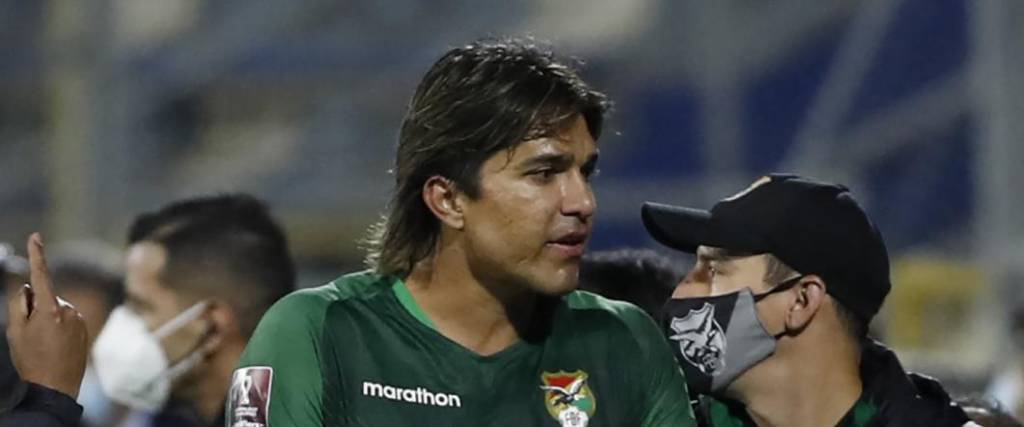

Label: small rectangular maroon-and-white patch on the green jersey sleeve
[226,367,273,427]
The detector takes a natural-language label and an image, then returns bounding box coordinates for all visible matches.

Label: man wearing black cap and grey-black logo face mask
[642,175,971,427]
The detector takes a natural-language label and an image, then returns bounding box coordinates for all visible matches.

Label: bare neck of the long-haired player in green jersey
[406,241,538,355]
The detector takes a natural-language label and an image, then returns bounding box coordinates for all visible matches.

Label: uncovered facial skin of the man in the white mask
[125,242,203,364]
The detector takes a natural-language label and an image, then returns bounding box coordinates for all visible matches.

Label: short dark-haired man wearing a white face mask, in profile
[92,195,295,426]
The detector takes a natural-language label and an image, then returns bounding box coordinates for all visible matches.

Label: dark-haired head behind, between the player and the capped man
[580,245,686,318]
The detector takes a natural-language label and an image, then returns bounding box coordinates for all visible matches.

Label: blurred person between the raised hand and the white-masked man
[48,241,126,427]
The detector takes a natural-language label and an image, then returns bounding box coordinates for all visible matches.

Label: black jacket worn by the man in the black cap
[694,341,969,427]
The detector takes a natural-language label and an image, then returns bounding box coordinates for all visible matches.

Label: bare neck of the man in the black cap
[737,342,862,427]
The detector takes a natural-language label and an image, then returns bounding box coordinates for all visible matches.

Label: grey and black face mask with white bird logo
[662,277,801,394]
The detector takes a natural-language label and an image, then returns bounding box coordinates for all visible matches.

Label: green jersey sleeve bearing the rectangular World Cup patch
[225,290,328,427]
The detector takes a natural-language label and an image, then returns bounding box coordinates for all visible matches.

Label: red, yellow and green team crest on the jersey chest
[541,371,597,427]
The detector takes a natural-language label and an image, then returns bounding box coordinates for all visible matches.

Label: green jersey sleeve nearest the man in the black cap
[624,307,696,427]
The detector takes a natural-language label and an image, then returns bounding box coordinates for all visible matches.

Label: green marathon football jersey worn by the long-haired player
[226,272,695,427]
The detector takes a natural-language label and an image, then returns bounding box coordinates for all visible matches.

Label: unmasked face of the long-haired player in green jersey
[464,117,597,295]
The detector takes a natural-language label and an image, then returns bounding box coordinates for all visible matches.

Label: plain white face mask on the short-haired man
[92,302,207,411]
